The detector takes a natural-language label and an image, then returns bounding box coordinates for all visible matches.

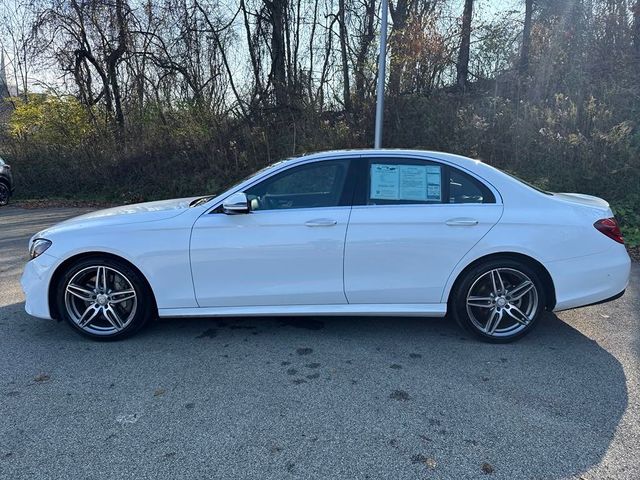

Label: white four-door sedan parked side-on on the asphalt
[22,150,630,342]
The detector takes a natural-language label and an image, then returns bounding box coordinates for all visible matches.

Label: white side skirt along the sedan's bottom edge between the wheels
[158,303,447,317]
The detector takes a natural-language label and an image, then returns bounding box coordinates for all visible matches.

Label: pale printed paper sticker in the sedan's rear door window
[370,164,442,202]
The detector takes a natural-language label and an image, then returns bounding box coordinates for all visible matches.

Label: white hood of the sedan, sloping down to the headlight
[34,197,198,238]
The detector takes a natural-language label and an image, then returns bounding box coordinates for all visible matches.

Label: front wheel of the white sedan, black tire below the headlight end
[54,256,156,341]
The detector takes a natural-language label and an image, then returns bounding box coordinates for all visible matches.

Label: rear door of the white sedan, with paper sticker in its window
[344,157,502,304]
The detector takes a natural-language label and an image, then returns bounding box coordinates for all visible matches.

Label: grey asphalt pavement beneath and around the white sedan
[0,207,640,480]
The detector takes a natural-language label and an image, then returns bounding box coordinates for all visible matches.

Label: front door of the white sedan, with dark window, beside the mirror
[191,159,354,307]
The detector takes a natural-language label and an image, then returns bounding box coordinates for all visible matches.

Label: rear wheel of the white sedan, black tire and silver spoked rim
[449,258,546,343]
